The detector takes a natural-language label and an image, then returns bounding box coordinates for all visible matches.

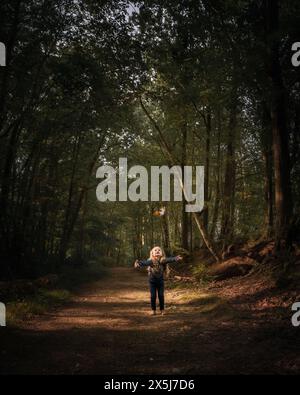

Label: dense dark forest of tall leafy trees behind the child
[0,0,300,278]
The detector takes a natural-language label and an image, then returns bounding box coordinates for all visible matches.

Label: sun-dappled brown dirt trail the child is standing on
[0,268,300,374]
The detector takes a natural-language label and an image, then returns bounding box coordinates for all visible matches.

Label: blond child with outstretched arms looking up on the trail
[134,247,182,315]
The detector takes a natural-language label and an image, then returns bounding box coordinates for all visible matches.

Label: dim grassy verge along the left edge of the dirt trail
[6,263,107,327]
